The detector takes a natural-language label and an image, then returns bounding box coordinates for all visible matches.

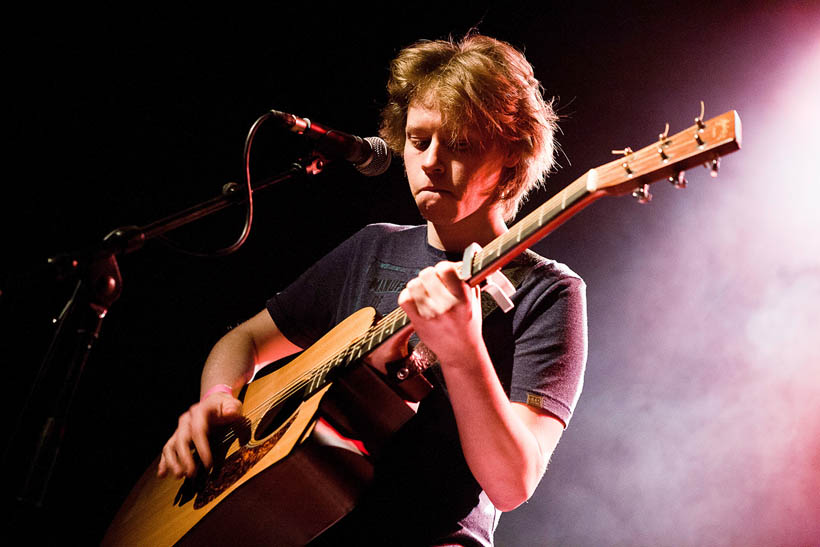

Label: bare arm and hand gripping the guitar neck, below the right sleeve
[399,262,564,511]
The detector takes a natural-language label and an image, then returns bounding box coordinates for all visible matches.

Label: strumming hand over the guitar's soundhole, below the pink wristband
[157,392,242,478]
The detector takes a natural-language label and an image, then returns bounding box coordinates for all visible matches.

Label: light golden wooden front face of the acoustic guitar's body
[102,308,375,546]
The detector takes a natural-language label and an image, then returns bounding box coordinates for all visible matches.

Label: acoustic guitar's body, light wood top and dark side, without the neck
[102,308,382,546]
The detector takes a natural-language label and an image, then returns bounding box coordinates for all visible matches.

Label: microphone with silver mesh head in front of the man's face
[271,110,391,177]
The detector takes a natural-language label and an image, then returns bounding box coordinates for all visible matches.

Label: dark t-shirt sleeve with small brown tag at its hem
[510,276,587,426]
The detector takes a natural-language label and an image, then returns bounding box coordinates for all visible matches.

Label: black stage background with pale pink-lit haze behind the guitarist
[0,2,820,545]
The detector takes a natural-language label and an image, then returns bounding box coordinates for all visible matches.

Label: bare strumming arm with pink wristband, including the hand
[157,310,301,478]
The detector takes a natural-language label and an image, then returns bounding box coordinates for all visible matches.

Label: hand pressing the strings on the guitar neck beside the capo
[399,262,484,366]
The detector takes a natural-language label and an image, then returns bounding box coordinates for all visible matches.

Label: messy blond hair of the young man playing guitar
[379,34,558,220]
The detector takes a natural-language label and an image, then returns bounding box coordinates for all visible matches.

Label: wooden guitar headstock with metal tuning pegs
[586,103,741,202]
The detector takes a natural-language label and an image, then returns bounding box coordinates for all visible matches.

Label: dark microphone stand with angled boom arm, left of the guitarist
[12,155,326,509]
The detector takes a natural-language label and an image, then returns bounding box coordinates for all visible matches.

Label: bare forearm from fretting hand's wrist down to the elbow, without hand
[442,344,557,511]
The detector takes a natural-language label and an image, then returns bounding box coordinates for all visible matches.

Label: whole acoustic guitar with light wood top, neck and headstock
[103,110,741,547]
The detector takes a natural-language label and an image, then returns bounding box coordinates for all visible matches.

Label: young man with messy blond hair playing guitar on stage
[159,35,586,545]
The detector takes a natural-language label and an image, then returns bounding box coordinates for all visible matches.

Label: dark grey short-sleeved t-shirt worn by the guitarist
[267,224,586,545]
